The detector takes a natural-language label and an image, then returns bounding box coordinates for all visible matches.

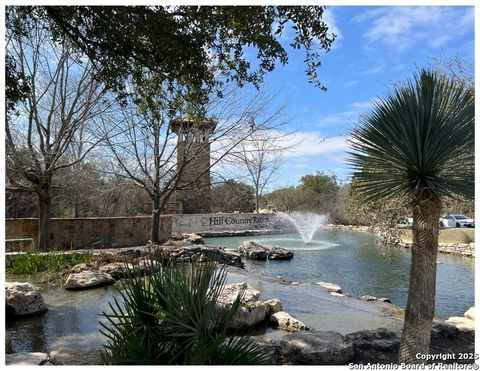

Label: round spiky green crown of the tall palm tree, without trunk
[350,70,474,201]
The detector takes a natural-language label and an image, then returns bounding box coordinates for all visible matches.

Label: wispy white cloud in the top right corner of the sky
[354,6,475,52]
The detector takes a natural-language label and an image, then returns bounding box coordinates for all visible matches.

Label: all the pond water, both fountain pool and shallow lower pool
[6,230,474,352]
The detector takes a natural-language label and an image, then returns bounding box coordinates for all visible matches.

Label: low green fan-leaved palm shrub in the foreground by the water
[100,261,266,365]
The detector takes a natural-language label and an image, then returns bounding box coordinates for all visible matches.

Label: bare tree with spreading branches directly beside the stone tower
[101,81,281,241]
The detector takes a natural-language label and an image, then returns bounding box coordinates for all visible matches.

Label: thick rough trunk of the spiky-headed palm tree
[398,191,442,364]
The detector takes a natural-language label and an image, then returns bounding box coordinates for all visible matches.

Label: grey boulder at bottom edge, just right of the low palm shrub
[280,331,353,365]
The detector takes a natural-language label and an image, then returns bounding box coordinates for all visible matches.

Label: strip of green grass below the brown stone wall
[5,250,93,274]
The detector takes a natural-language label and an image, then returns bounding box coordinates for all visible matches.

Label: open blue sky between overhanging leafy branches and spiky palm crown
[265,6,475,189]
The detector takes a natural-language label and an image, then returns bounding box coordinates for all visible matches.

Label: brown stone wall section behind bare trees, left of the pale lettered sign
[5,215,172,249]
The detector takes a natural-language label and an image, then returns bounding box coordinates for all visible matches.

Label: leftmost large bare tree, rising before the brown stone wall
[5,18,105,249]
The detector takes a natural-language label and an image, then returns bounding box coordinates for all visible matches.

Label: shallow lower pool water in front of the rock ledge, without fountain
[6,267,402,352]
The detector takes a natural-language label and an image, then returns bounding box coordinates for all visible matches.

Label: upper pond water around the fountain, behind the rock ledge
[205,229,475,318]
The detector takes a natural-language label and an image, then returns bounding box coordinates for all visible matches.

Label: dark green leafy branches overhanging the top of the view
[6,6,335,106]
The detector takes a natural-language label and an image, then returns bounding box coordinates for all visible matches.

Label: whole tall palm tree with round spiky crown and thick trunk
[350,69,474,363]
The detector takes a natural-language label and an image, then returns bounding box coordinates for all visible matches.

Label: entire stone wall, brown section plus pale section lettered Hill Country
[5,213,283,251]
